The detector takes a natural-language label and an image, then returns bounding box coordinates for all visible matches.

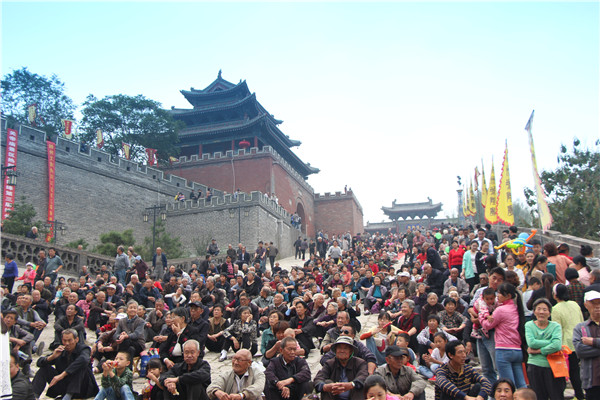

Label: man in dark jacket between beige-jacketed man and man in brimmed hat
[265,337,314,400]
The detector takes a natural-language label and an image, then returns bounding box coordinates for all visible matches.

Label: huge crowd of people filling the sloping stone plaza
[1,226,600,400]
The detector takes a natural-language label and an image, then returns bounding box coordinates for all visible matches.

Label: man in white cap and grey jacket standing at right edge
[573,290,600,399]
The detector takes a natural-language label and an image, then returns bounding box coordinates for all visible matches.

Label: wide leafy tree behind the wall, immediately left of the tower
[80,94,184,162]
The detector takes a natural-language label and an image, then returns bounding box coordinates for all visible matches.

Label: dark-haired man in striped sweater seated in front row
[435,340,492,400]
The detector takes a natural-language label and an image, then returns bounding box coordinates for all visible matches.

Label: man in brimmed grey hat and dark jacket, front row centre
[315,336,369,400]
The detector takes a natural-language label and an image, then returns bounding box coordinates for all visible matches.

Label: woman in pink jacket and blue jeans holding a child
[482,283,527,388]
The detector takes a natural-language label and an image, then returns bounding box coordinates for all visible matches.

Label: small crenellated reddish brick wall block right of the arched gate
[314,195,364,236]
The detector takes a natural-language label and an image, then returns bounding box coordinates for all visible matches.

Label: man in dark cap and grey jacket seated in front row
[375,346,427,400]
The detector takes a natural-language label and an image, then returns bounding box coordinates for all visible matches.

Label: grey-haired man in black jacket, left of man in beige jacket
[160,339,210,400]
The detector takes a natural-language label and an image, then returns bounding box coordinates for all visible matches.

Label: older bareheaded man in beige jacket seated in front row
[206,349,265,400]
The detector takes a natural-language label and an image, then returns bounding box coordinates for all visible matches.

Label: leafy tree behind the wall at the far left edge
[1,67,76,136]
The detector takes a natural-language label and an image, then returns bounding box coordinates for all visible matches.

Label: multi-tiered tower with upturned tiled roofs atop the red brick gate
[171,71,319,179]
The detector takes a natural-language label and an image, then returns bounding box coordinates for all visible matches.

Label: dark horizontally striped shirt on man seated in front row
[435,363,492,400]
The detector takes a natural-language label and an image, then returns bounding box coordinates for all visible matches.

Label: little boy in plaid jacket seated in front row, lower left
[95,351,134,400]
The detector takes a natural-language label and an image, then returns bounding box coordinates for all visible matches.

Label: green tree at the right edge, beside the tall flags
[525,139,600,240]
